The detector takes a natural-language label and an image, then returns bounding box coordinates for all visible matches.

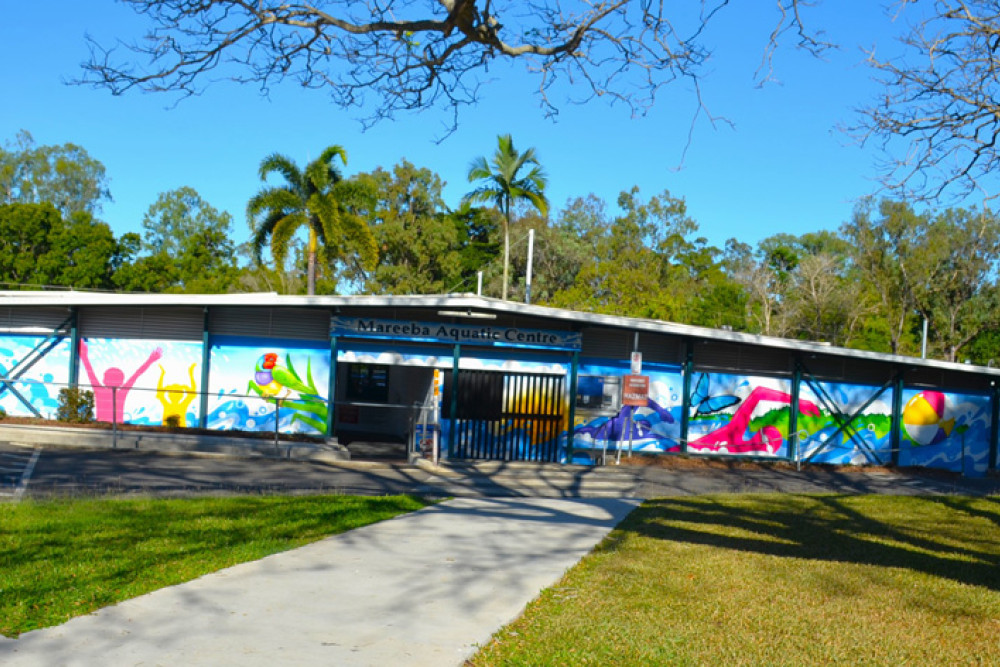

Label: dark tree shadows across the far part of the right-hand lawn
[599,495,1000,591]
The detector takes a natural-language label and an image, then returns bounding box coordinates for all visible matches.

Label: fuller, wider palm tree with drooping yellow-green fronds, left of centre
[247,145,377,295]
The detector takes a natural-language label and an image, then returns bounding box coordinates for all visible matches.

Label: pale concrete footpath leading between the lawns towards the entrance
[0,498,638,667]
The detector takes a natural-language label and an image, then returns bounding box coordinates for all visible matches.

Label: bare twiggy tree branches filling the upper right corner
[854,0,1000,200]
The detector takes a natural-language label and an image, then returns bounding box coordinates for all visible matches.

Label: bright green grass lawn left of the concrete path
[0,496,426,637]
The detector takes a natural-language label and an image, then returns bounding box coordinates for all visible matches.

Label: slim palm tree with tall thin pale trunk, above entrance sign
[464,134,549,301]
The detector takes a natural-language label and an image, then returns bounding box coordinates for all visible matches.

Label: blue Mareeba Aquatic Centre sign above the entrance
[330,317,582,350]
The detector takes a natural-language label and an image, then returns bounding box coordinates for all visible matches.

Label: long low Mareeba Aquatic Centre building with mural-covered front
[0,292,1000,475]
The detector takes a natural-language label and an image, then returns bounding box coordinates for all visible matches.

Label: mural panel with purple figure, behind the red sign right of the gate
[573,359,684,463]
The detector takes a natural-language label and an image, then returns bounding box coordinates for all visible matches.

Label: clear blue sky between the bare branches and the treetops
[0,0,916,252]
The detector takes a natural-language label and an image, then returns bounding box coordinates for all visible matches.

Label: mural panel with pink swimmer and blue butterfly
[688,373,819,457]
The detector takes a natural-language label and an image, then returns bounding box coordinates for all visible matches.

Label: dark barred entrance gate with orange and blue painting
[450,370,565,461]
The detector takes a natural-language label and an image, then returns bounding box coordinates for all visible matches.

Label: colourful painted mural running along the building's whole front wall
[0,334,991,475]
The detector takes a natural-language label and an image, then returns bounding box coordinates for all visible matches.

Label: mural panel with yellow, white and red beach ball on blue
[899,389,990,475]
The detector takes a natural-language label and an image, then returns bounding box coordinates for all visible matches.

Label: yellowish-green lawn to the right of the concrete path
[472,495,1000,667]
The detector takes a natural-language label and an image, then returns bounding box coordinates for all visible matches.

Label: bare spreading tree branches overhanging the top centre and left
[77,0,823,133]
